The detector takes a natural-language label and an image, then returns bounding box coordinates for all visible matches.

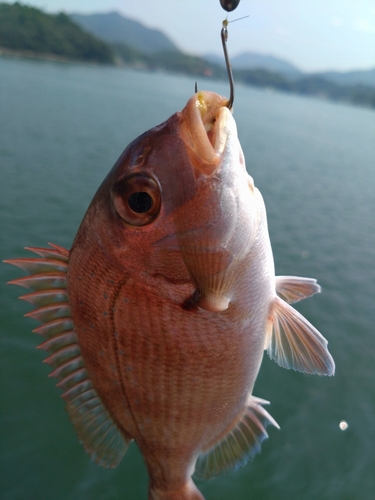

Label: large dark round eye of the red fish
[113,174,161,226]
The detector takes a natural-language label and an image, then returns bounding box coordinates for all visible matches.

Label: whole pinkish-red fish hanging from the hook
[6,91,335,500]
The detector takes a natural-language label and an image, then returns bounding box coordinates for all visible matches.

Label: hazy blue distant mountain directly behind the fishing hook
[205,52,303,78]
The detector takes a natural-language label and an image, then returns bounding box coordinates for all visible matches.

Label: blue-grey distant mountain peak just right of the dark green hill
[70,12,180,54]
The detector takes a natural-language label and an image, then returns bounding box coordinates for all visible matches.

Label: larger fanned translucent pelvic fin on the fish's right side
[266,297,335,375]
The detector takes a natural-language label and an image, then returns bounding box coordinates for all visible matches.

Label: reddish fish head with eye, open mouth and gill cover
[73,92,258,311]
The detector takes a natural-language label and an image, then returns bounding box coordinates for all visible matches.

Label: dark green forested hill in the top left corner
[0,2,113,63]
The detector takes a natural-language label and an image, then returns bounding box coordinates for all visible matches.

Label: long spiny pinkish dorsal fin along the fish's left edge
[5,243,130,467]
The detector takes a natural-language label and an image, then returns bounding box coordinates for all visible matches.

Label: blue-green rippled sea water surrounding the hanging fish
[0,57,375,500]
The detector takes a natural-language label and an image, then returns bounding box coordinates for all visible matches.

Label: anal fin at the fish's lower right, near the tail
[195,396,279,479]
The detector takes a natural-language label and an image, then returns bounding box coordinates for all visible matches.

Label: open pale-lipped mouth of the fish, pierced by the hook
[180,91,233,175]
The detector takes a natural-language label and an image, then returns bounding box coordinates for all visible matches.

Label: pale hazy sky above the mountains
[23,0,375,71]
